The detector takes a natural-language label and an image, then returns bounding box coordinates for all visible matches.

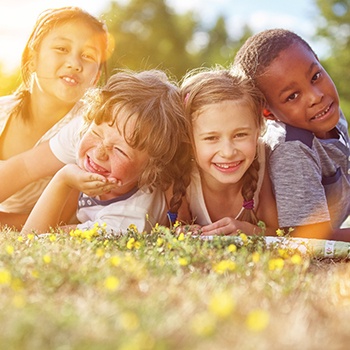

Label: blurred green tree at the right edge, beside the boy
[316,0,350,121]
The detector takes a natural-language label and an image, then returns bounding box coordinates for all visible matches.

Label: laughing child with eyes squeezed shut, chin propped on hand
[22,71,188,233]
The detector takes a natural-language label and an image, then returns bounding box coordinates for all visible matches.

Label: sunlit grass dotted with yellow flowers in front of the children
[0,226,350,350]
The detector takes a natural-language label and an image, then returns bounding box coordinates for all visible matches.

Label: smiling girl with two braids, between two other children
[180,66,277,235]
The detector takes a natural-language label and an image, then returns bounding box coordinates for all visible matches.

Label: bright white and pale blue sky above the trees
[0,0,326,71]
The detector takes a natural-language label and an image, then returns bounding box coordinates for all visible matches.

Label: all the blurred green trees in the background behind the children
[0,0,350,121]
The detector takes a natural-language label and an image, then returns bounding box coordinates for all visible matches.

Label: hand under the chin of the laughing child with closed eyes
[57,164,117,197]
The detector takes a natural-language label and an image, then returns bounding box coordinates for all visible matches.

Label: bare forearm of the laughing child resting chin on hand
[22,164,81,233]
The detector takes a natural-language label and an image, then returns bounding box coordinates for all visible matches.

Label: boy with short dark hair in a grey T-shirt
[233,29,350,241]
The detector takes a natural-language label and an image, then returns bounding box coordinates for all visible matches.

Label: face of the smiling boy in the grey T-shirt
[257,43,339,138]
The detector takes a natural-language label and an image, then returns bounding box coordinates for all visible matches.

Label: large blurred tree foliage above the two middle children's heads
[104,0,243,79]
